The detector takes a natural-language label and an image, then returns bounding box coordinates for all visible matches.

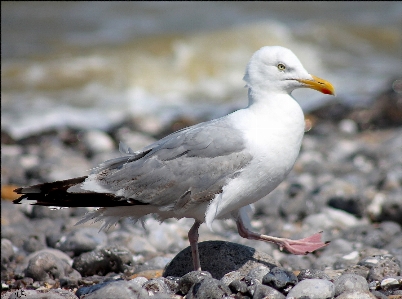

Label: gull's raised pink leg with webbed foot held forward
[236,217,329,254]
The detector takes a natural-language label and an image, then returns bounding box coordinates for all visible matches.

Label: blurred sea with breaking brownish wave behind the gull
[1,1,402,140]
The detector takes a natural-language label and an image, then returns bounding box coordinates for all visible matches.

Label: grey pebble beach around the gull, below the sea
[1,79,402,299]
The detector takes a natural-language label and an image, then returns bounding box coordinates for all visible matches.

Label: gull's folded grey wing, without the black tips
[90,119,251,210]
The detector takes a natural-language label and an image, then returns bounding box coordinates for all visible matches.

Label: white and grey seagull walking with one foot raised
[14,46,335,270]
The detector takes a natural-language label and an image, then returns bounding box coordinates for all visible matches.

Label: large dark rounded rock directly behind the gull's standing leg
[163,241,279,279]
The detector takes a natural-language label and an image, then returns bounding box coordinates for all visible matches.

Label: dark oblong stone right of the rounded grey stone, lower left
[73,246,133,276]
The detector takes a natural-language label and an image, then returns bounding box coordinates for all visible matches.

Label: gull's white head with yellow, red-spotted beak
[244,46,335,95]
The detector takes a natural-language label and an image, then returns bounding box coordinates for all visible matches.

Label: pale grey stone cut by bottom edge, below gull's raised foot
[286,279,335,299]
